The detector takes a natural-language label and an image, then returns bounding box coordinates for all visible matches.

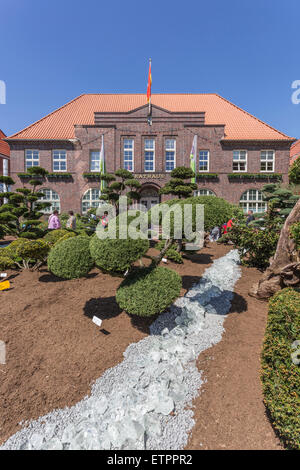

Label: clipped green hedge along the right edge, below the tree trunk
[262,288,300,450]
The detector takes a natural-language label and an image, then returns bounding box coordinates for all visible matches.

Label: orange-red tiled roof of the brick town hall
[5,93,294,140]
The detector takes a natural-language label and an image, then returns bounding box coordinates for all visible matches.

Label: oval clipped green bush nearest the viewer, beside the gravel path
[116,266,182,317]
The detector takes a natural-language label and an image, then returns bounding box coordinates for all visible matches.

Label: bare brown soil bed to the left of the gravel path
[0,245,230,442]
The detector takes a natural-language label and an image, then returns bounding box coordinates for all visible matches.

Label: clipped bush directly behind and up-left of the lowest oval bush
[90,235,149,272]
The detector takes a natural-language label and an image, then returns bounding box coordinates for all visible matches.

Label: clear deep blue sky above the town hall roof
[0,0,300,137]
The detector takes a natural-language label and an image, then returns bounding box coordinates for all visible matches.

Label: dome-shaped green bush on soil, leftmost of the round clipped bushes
[48,237,94,279]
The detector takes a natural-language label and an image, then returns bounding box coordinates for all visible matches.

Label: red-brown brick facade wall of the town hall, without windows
[10,107,290,212]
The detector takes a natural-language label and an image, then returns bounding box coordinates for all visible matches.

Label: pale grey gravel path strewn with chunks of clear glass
[0,250,241,450]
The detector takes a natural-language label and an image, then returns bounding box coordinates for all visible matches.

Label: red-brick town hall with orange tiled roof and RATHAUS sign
[6,94,295,212]
